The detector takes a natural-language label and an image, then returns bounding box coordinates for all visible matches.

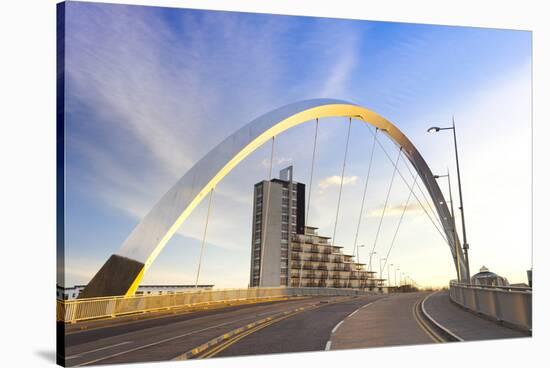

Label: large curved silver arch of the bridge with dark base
[82,99,465,297]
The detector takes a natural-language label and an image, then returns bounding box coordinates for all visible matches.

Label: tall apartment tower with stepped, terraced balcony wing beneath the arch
[250,166,381,290]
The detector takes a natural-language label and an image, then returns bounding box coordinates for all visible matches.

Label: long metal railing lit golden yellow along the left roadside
[57,287,367,323]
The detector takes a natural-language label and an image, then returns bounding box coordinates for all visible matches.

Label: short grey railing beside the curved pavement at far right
[449,281,533,331]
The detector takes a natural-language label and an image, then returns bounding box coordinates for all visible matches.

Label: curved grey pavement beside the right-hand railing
[424,291,531,341]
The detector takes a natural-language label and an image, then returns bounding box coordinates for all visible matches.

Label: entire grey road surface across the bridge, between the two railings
[60,292,525,366]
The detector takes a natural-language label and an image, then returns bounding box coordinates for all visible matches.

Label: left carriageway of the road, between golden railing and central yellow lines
[61,297,362,366]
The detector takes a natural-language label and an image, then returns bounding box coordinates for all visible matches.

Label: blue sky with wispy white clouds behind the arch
[64,2,532,288]
